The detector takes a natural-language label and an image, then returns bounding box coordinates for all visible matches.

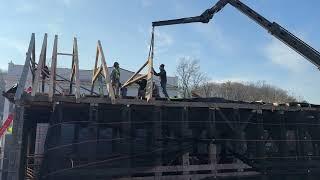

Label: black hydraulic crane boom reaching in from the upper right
[152,0,320,69]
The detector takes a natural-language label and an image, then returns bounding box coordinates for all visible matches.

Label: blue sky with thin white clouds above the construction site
[0,0,320,104]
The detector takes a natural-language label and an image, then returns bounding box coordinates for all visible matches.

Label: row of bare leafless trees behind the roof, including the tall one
[177,57,302,103]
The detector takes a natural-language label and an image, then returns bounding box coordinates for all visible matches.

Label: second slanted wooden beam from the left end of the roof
[31,33,48,96]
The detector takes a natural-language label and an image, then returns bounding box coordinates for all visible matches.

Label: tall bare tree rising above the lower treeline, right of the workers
[177,57,207,98]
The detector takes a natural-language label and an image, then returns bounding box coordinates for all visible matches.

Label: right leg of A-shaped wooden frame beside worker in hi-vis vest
[98,40,116,103]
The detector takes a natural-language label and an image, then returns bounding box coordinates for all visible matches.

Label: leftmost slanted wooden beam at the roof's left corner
[14,33,35,101]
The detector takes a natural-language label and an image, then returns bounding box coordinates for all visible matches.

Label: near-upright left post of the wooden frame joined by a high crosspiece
[49,35,58,101]
